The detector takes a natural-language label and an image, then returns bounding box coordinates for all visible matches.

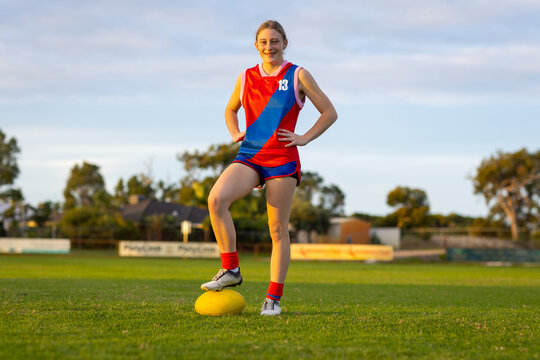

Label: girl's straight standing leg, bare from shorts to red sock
[266,177,296,284]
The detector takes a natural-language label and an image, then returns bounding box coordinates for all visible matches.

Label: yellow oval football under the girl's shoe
[195,289,246,316]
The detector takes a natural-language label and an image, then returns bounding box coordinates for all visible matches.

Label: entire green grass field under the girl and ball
[0,254,540,359]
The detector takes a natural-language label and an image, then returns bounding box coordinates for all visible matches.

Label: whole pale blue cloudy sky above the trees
[0,0,540,216]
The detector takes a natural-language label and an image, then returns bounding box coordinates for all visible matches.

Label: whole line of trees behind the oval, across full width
[0,129,540,239]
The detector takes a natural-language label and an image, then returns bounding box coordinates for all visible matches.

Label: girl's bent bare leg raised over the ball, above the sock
[208,163,259,253]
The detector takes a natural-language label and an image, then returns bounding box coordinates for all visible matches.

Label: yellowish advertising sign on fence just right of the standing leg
[291,244,394,261]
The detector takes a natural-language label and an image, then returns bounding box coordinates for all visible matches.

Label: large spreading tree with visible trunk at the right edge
[472,149,540,240]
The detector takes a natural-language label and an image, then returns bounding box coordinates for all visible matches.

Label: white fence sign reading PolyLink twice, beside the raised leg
[118,241,219,258]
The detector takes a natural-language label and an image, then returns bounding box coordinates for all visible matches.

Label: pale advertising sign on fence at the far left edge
[0,238,71,254]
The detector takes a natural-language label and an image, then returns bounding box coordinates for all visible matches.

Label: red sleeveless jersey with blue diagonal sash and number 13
[238,61,304,169]
